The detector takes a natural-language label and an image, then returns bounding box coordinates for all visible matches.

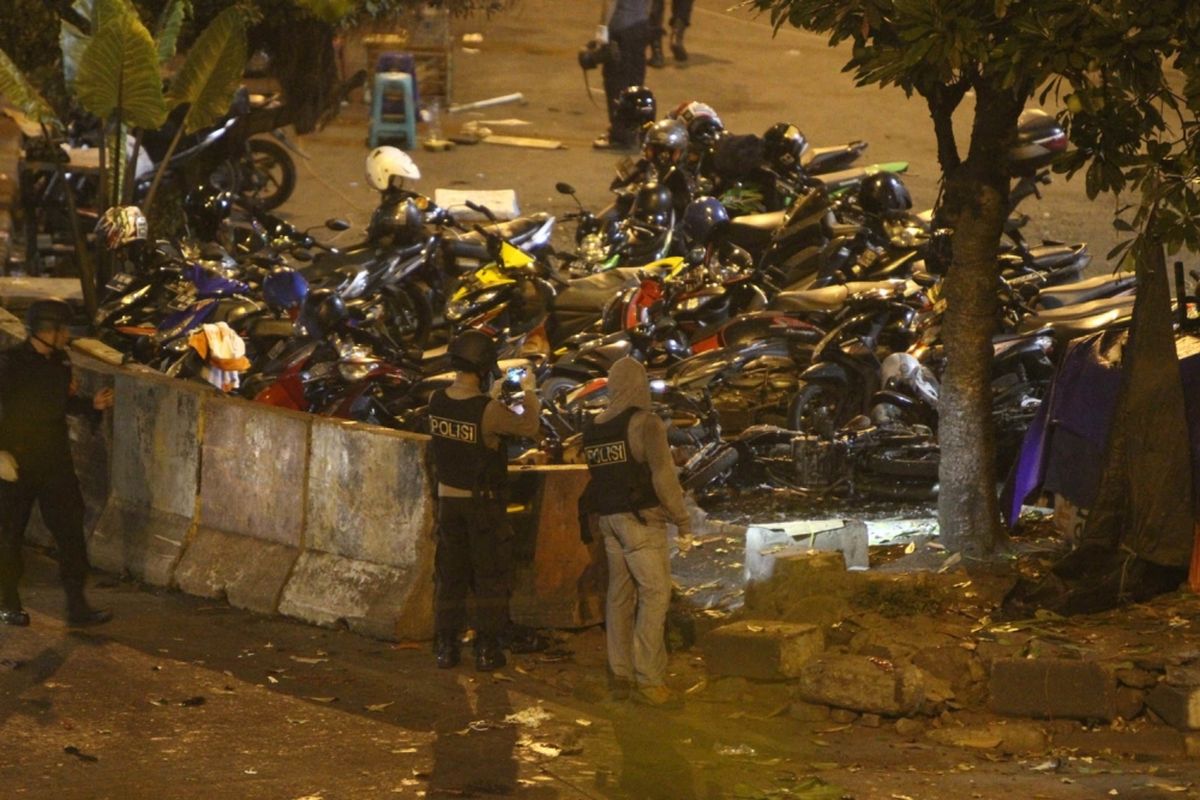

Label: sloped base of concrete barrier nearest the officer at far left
[88,498,192,587]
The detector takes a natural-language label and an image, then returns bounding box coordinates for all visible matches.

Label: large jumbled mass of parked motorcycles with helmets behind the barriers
[88,102,1134,499]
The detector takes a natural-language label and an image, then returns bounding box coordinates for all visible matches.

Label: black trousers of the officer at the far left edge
[0,459,88,610]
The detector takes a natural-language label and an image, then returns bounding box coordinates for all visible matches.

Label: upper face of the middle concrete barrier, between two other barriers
[199,397,312,548]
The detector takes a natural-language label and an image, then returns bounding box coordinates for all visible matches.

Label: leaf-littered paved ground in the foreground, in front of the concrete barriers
[7,555,1200,800]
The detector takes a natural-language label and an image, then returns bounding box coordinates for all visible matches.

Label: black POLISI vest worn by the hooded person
[583,408,659,515]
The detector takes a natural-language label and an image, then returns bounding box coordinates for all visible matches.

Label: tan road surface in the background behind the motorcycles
[286,0,1117,270]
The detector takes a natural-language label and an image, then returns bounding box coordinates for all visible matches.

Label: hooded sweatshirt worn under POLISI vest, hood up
[596,356,691,534]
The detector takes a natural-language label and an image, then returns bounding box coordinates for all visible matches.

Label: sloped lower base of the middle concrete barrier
[175,528,299,614]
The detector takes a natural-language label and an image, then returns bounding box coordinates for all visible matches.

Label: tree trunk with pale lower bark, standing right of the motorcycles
[937,82,1021,557]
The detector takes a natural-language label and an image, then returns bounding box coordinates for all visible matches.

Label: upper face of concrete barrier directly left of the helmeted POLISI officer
[304,419,433,572]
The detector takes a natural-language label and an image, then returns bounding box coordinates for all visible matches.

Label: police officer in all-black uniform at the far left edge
[0,300,113,626]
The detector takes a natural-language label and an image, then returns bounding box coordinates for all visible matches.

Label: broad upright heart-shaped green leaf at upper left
[74,14,167,128]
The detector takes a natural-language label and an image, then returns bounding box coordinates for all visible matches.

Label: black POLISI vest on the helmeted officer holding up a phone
[430,391,508,495]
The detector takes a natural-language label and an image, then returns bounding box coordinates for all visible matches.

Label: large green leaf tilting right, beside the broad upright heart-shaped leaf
[167,7,246,134]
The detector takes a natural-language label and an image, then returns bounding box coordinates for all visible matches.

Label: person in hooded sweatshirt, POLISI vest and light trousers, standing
[581,357,691,706]
